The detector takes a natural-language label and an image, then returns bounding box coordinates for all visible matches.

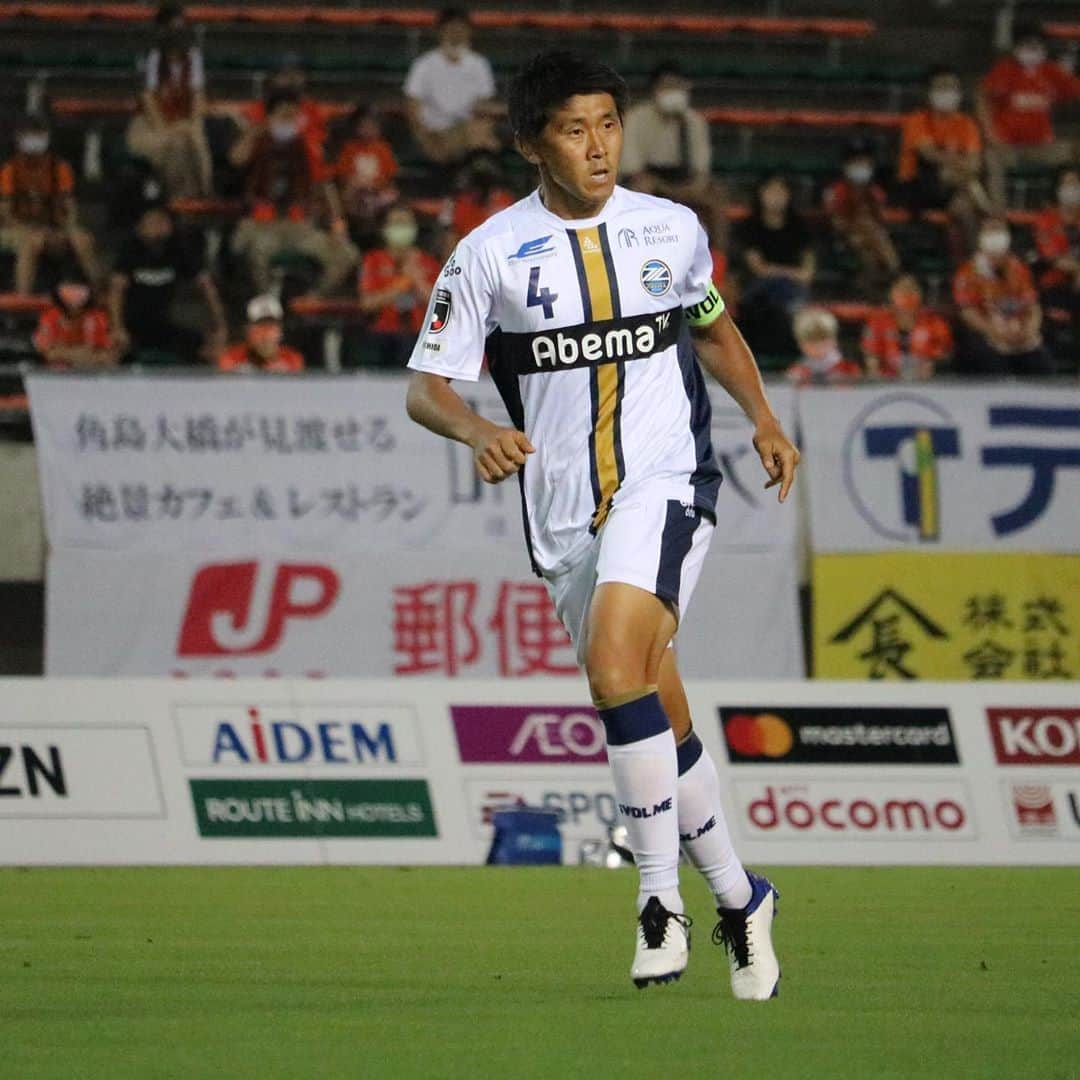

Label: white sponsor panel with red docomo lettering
[734,778,975,841]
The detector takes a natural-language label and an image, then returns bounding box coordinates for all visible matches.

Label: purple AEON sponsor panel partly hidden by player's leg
[450,705,607,765]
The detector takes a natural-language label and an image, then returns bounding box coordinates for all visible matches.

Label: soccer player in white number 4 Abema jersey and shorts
[407,51,799,1000]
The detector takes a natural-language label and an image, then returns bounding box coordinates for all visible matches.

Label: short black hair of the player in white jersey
[509,49,630,138]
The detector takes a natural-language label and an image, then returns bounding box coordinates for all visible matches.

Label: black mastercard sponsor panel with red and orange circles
[719,705,960,765]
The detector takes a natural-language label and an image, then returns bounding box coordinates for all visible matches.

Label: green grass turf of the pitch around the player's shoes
[0,868,1080,1080]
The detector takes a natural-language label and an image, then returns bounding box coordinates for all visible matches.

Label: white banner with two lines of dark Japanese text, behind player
[27,375,796,559]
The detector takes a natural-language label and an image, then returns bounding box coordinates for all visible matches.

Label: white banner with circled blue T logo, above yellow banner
[799,382,1080,553]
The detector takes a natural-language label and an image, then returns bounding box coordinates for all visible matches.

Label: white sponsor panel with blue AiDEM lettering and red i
[173,702,423,771]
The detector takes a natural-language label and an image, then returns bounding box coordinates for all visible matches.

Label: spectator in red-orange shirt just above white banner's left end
[33,264,117,370]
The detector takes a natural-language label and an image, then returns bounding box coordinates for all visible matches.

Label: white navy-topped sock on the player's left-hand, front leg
[599,693,683,915]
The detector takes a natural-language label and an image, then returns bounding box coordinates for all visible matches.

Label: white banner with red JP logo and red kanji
[45,548,804,678]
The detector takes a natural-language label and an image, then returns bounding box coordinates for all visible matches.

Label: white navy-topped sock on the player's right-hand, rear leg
[677,731,752,908]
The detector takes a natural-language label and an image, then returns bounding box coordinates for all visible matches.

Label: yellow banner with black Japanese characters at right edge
[813,552,1080,679]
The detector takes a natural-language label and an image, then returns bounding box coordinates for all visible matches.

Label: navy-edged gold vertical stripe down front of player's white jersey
[570,225,625,532]
